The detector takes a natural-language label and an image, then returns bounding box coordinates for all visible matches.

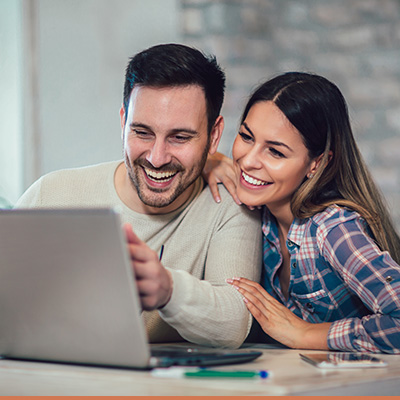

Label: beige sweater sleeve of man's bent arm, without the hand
[159,188,262,348]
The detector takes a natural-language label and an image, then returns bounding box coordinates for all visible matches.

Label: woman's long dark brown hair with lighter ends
[241,72,400,263]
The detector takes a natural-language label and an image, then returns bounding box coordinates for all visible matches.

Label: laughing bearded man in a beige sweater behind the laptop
[17,44,261,347]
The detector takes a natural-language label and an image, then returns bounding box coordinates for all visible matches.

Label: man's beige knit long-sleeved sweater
[16,161,261,348]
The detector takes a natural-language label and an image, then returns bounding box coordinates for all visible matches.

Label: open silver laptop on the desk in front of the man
[0,209,262,368]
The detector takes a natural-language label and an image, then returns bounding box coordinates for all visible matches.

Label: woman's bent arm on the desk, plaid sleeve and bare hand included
[228,211,400,353]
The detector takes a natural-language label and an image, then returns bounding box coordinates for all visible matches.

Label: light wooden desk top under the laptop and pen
[0,345,400,396]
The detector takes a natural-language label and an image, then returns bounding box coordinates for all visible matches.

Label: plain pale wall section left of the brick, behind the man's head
[39,0,178,172]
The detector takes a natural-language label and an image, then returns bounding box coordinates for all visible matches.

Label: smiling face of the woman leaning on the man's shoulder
[232,101,316,213]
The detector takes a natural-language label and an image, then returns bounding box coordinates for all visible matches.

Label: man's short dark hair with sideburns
[124,44,225,133]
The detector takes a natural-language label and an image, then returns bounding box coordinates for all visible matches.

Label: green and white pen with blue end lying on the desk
[151,367,270,379]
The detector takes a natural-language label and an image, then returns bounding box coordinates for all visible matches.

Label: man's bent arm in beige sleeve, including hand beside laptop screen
[126,188,261,348]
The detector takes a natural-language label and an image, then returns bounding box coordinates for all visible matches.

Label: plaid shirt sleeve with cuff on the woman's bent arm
[318,218,400,353]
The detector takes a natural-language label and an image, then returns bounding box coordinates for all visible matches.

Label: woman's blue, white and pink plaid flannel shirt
[262,206,400,353]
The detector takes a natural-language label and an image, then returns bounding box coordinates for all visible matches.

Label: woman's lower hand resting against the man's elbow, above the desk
[227,278,330,350]
